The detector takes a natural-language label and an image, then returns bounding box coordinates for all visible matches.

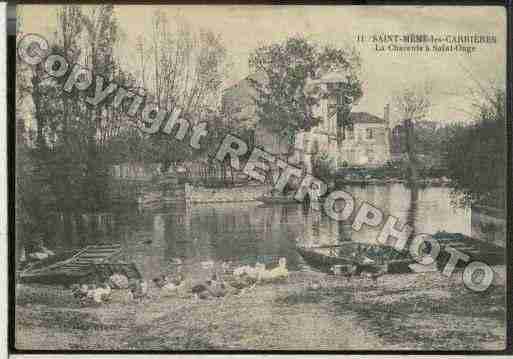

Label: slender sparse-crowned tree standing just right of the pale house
[392,82,432,183]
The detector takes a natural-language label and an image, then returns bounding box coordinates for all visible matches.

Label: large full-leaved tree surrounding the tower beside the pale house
[249,36,363,157]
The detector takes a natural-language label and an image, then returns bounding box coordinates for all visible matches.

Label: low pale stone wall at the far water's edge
[185,184,268,203]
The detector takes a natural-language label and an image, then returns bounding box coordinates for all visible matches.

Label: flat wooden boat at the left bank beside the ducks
[18,244,141,286]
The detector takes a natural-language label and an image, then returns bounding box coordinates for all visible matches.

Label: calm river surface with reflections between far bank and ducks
[43,184,471,278]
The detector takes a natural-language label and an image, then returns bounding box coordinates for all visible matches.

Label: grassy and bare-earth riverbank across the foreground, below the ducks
[16,266,506,350]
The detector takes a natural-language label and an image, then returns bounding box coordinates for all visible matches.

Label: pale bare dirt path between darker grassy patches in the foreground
[112,272,385,350]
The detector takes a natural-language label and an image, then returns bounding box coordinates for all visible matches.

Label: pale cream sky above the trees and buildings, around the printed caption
[22,5,506,126]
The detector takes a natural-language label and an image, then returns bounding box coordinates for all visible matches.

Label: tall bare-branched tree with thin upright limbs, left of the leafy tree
[136,10,226,169]
